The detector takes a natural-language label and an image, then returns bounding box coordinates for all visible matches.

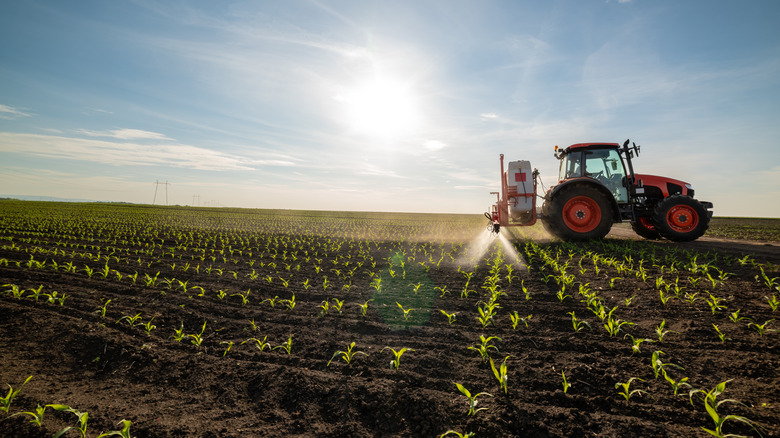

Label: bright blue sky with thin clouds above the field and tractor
[0,0,780,217]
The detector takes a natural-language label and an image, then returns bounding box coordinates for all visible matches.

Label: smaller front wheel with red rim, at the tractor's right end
[653,195,710,242]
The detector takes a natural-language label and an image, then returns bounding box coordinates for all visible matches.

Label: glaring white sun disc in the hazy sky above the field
[338,78,420,139]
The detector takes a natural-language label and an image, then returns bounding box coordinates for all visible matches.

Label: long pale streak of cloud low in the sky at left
[0,130,272,171]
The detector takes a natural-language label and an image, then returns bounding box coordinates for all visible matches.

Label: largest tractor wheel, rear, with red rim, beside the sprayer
[542,184,612,241]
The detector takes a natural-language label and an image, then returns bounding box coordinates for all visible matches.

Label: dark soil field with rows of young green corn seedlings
[0,202,780,438]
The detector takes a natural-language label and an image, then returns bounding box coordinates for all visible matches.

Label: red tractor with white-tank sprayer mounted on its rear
[485,140,712,242]
